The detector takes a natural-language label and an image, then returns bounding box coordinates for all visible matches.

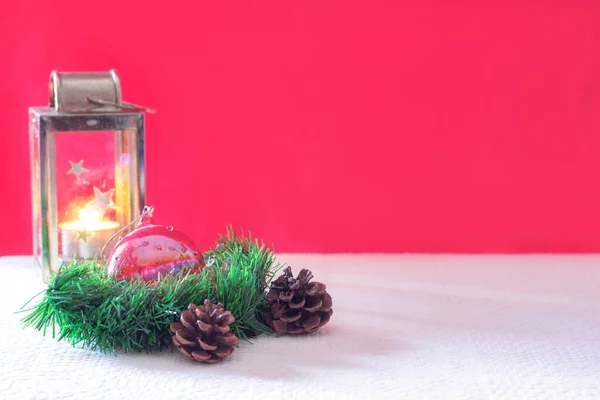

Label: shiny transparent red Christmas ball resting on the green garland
[107,207,203,281]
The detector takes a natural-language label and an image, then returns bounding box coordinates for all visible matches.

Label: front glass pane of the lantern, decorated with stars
[52,131,120,262]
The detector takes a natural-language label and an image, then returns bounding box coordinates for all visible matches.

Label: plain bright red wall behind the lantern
[0,0,600,254]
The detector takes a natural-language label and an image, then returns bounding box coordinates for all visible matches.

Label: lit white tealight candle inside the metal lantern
[59,206,119,259]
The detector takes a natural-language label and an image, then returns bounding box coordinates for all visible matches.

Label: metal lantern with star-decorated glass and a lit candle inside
[29,70,145,279]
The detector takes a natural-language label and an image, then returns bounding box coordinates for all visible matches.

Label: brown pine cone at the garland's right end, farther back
[265,267,333,335]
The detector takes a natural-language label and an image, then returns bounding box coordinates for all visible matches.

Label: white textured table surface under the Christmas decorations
[0,255,600,400]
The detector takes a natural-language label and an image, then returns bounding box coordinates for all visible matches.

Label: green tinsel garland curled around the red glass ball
[23,230,279,353]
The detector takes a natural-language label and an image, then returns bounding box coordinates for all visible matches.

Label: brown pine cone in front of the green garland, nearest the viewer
[171,300,240,364]
